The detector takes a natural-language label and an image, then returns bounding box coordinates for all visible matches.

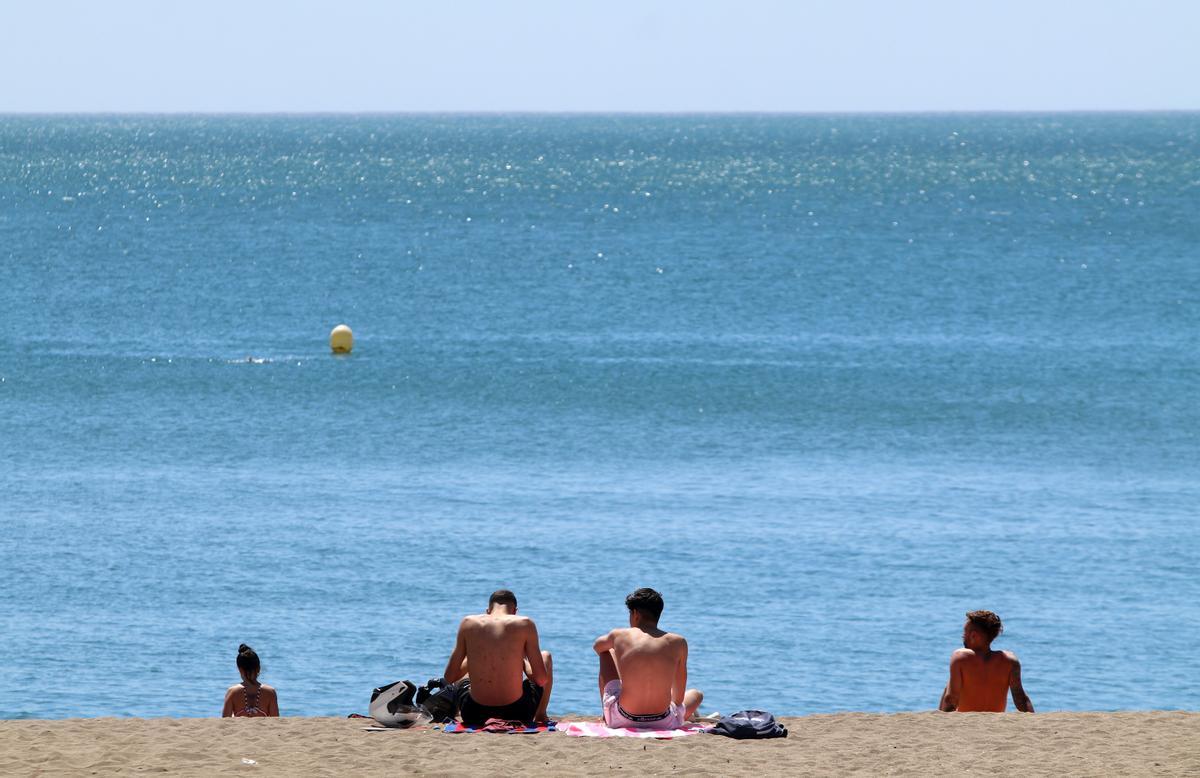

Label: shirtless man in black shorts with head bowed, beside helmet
[445,590,553,726]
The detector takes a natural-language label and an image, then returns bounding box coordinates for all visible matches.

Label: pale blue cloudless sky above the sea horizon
[0,0,1200,113]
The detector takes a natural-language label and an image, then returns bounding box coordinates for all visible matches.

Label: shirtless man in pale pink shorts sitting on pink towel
[592,588,704,730]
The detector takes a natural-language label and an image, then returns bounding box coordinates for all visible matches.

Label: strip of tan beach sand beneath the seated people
[0,712,1200,776]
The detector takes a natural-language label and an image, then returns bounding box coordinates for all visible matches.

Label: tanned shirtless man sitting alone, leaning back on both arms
[938,611,1033,713]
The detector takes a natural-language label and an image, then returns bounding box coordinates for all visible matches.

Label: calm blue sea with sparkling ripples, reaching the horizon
[0,114,1200,718]
